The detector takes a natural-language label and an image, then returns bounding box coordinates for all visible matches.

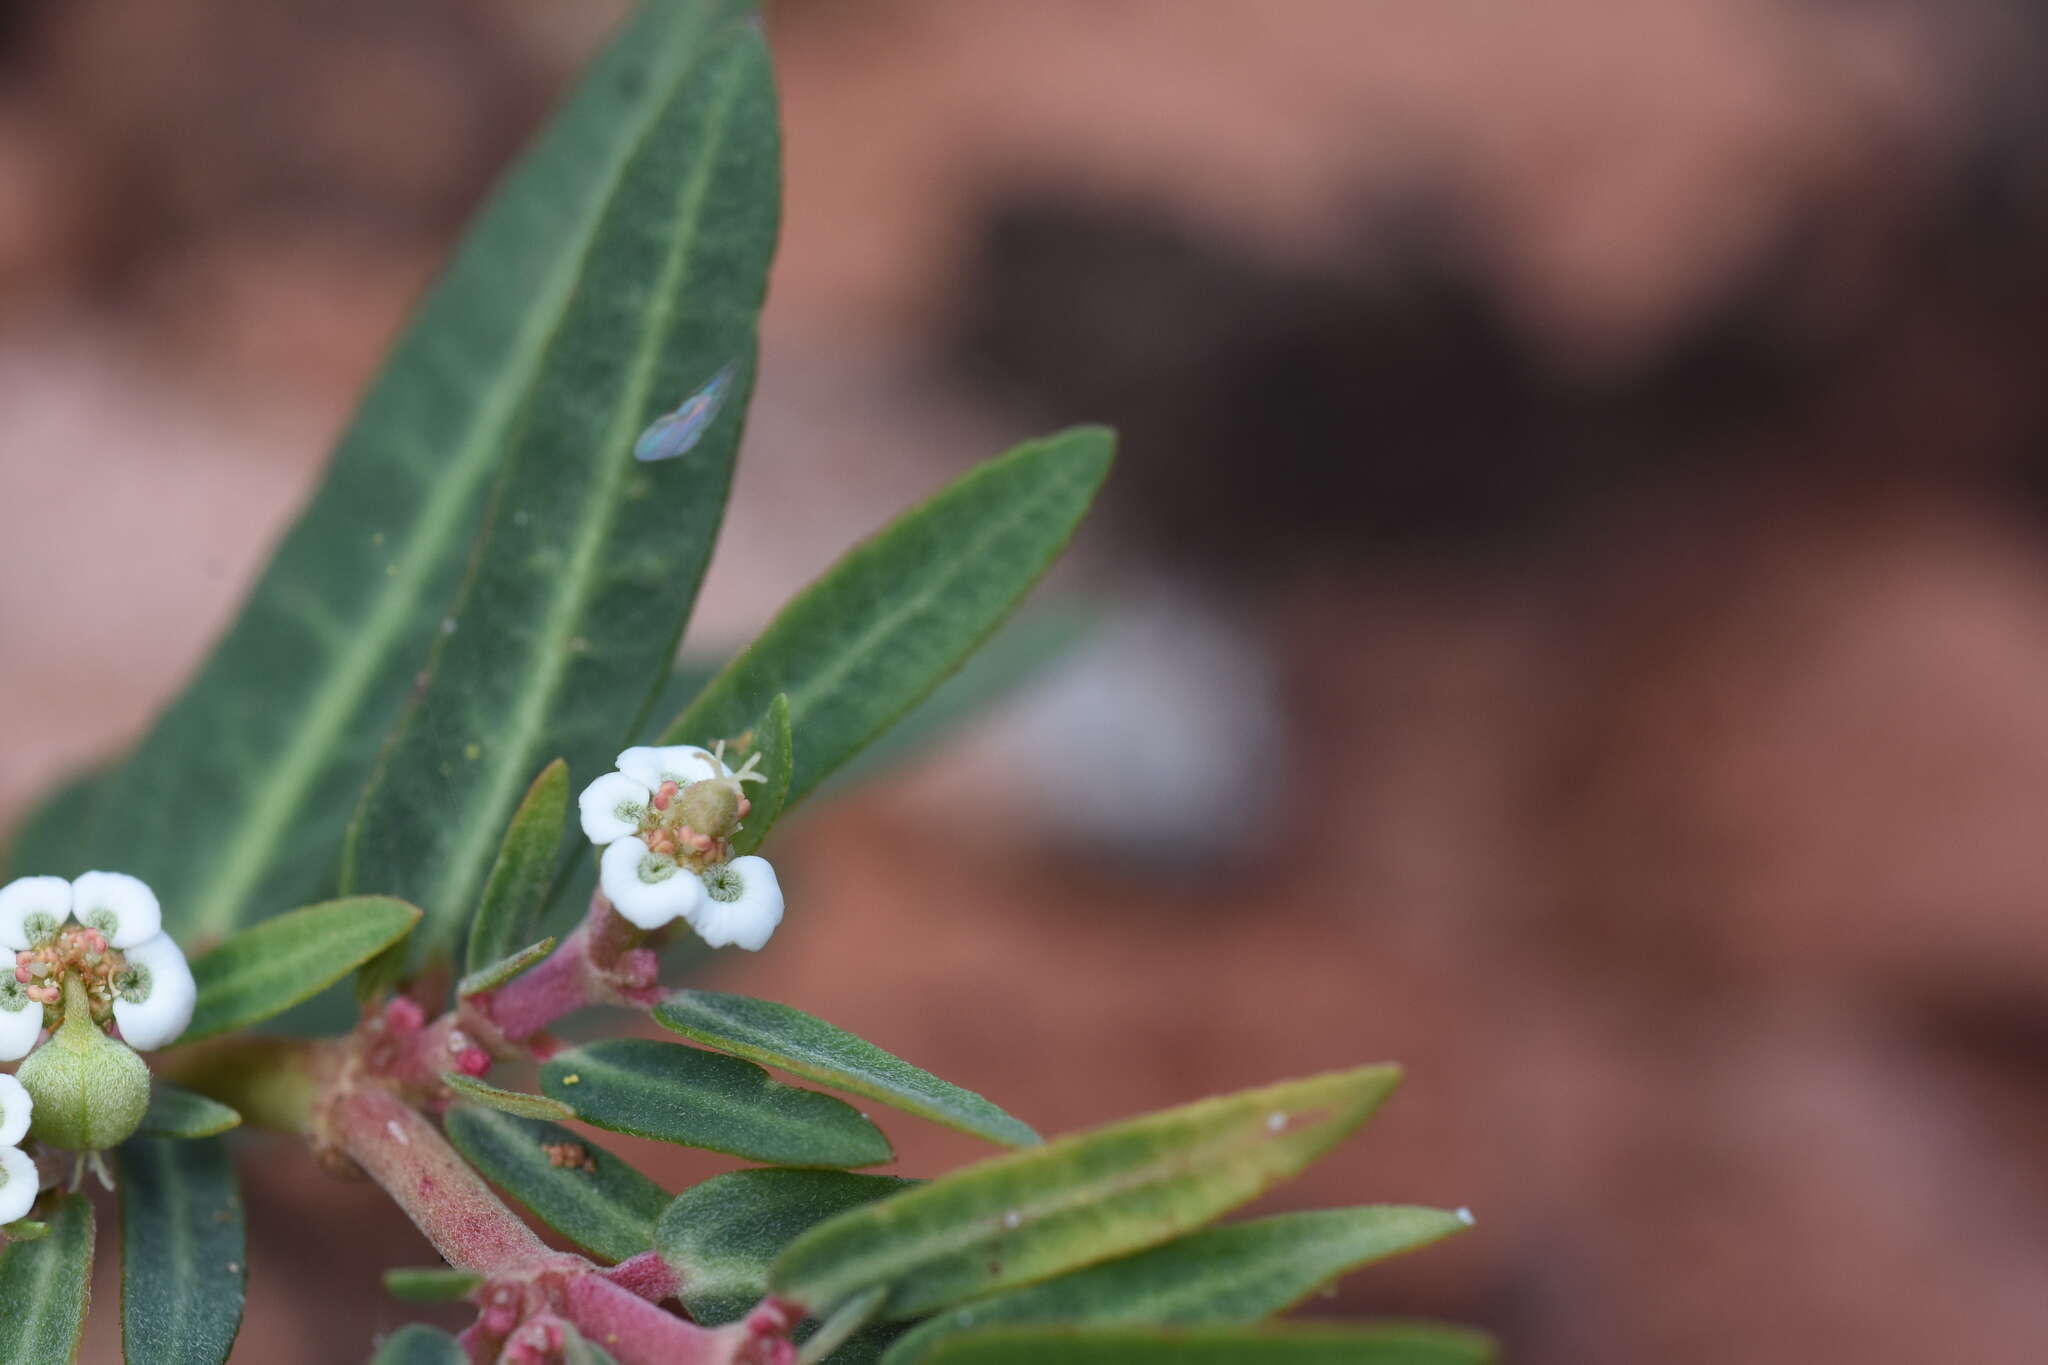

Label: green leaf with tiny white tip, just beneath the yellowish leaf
[889,1205,1470,1365]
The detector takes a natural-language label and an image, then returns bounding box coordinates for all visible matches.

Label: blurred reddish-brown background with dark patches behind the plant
[0,0,2048,1365]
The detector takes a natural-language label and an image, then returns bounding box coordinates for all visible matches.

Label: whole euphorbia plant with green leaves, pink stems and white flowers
[0,0,1489,1365]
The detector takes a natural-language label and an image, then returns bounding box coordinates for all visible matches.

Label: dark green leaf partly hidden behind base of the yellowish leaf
[653,1166,918,1326]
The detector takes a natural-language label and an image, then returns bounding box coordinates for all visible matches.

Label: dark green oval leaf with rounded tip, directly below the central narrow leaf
[541,1038,895,1166]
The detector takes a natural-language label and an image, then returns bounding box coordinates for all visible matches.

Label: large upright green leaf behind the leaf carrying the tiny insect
[19,0,770,943]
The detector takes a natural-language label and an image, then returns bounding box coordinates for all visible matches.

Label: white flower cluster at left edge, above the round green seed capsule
[0,872,199,1062]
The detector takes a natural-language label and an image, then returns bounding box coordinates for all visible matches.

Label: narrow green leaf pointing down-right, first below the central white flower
[653,990,1038,1146]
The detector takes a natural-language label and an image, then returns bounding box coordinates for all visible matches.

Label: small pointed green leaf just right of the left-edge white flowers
[178,896,420,1044]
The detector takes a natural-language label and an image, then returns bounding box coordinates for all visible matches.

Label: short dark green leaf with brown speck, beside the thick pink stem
[446,1105,668,1261]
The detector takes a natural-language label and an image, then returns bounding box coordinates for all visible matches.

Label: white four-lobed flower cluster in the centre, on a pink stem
[593,745,782,950]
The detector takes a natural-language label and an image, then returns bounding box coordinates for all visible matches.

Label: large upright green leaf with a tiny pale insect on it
[342,25,778,950]
